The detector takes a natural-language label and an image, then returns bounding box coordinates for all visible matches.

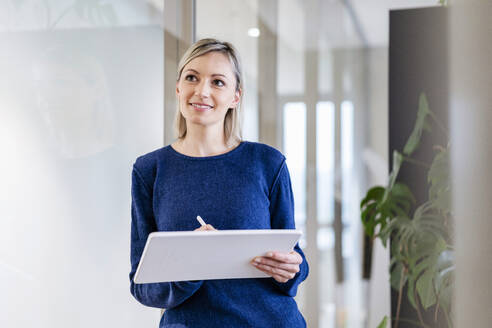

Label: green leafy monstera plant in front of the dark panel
[361,93,454,327]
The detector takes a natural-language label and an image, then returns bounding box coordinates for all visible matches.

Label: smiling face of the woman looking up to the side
[176,51,241,129]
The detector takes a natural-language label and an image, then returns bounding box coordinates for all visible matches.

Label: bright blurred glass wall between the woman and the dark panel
[195,0,435,327]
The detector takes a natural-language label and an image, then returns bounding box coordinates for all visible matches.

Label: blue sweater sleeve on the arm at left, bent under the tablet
[130,167,203,309]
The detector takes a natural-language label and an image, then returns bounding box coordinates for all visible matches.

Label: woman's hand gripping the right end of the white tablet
[251,251,302,283]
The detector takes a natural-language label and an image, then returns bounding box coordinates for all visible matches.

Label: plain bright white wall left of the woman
[0,0,163,328]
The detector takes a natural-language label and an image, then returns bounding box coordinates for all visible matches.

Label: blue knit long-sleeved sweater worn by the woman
[130,142,308,328]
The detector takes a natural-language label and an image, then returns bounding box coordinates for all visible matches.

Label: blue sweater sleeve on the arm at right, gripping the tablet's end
[270,159,309,297]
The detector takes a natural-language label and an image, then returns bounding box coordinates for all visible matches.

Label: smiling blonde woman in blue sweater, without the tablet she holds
[130,39,308,327]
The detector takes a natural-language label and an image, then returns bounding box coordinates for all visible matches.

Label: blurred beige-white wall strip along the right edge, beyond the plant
[448,0,492,328]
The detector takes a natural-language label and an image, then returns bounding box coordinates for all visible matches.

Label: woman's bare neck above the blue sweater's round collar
[174,125,236,157]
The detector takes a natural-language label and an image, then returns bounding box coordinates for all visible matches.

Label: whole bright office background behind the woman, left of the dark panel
[0,0,490,328]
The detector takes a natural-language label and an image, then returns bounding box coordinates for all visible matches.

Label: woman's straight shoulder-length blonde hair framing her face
[174,39,243,146]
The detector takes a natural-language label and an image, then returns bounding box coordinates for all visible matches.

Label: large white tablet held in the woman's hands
[134,229,302,284]
